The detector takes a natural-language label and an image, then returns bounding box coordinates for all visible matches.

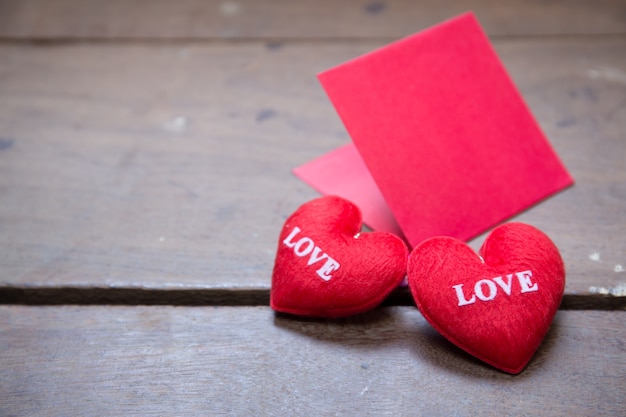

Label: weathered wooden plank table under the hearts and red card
[0,0,626,416]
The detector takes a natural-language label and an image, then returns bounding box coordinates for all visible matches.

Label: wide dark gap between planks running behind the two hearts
[0,287,626,310]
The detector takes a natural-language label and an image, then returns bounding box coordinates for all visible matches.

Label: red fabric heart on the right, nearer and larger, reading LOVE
[408,223,565,374]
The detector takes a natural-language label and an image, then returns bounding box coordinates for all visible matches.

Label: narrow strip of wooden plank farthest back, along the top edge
[0,0,626,39]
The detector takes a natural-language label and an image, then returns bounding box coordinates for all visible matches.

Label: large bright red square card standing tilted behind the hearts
[312,13,573,245]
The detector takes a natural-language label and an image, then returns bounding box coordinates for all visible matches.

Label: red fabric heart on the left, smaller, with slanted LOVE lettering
[270,196,408,318]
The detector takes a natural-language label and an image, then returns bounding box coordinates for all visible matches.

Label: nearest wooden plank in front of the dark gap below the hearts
[0,306,626,416]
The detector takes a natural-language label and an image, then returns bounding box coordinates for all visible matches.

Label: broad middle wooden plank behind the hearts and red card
[0,38,626,294]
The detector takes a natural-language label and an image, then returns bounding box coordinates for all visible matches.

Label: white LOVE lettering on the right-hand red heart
[452,271,539,307]
